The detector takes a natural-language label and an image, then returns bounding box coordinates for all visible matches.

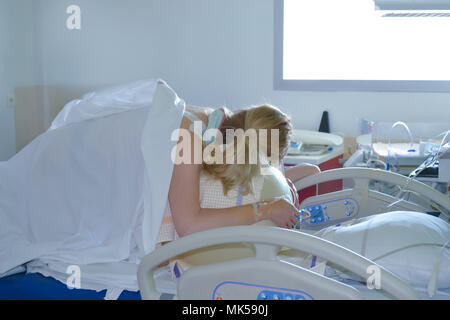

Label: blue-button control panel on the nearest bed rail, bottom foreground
[212,281,314,300]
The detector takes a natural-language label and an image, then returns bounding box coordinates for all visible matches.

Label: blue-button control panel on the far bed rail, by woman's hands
[303,198,358,226]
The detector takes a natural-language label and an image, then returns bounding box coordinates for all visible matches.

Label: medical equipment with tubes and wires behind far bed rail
[343,120,450,208]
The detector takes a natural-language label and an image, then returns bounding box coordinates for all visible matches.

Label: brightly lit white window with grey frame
[275,0,450,92]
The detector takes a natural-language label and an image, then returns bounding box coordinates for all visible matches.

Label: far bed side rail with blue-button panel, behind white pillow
[295,168,450,231]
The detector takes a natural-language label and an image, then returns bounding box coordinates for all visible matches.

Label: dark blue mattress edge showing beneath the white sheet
[0,273,141,300]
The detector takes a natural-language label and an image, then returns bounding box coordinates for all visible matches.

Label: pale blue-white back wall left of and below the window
[26,0,450,139]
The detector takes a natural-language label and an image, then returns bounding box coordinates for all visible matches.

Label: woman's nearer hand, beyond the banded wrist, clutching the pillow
[259,199,298,229]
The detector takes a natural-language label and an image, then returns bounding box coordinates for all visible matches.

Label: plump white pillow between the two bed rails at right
[316,211,450,288]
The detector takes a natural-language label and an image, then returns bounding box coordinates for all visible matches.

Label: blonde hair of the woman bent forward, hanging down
[203,105,292,195]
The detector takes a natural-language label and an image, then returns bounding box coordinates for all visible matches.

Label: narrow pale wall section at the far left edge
[0,0,38,161]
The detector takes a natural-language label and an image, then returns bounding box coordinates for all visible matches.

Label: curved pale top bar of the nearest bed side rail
[138,226,418,299]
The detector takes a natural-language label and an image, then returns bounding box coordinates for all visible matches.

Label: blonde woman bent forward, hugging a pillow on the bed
[169,105,320,236]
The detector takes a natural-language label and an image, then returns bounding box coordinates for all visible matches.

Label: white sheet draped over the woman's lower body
[0,82,184,289]
